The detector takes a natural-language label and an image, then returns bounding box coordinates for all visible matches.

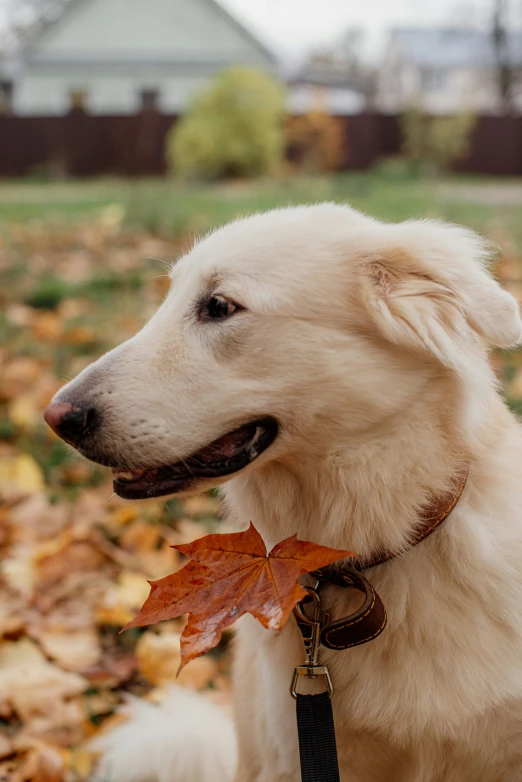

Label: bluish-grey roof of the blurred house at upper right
[392,27,522,69]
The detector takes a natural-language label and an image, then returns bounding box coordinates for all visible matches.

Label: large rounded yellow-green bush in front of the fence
[167,68,285,178]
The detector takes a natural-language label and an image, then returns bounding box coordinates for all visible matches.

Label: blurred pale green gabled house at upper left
[10,0,276,115]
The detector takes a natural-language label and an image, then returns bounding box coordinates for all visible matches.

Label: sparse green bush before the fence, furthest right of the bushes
[401,107,476,173]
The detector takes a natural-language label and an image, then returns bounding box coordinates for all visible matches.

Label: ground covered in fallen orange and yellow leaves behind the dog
[0,191,522,782]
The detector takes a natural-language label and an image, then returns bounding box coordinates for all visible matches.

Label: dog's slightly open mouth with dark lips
[112,417,278,500]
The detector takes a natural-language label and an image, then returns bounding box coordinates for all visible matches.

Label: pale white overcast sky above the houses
[0,0,522,61]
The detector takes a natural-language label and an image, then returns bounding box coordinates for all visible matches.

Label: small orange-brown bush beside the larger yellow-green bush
[286,109,346,174]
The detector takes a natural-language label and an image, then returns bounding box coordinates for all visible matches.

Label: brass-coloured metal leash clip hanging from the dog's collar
[290,586,333,700]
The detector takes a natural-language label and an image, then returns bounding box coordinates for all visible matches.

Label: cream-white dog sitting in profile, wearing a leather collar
[43,204,522,782]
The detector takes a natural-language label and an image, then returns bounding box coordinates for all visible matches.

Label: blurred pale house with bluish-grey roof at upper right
[377,28,522,114]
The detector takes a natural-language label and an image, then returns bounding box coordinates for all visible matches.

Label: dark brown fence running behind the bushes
[0,111,522,177]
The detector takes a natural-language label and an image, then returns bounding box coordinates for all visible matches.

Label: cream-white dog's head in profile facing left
[46,204,522,498]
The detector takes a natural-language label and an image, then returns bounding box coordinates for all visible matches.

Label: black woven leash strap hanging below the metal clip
[296,692,339,782]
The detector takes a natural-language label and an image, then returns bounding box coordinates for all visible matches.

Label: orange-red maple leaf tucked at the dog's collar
[123,524,355,670]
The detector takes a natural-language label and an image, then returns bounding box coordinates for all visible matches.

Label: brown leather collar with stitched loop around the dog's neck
[298,465,469,650]
